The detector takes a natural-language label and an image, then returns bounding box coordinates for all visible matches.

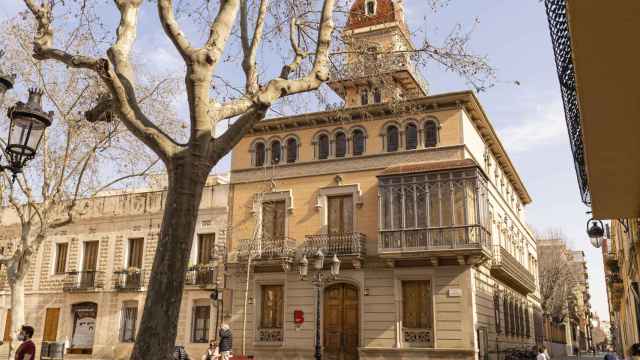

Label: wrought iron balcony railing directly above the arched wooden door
[303,232,367,257]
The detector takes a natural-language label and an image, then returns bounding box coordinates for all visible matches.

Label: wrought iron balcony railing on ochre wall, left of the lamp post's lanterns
[238,235,296,260]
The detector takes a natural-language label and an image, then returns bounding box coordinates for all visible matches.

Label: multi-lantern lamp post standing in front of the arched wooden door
[298,250,340,360]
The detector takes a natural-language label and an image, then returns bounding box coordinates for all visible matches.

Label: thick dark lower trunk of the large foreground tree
[131,161,211,360]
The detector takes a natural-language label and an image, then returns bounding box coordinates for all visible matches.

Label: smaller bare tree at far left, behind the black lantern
[0,19,171,353]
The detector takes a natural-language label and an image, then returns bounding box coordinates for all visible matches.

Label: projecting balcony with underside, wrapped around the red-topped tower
[329,53,429,96]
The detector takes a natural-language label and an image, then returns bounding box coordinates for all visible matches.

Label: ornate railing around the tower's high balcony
[331,52,429,92]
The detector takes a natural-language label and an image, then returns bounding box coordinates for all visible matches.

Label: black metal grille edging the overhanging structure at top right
[545,0,591,206]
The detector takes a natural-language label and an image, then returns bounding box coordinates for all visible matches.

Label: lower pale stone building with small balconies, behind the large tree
[0,176,228,359]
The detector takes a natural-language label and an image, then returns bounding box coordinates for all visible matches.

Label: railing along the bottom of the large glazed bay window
[378,225,491,253]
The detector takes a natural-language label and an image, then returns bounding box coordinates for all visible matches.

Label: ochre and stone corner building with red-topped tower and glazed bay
[227,0,543,359]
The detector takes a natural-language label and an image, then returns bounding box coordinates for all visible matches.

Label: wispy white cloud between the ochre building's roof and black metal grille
[499,99,567,152]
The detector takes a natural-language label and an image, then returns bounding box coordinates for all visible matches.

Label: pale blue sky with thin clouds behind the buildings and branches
[0,0,608,319]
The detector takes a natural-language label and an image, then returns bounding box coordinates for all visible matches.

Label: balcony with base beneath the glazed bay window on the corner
[378,225,491,264]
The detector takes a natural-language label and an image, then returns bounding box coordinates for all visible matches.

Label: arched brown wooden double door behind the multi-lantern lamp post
[323,284,360,360]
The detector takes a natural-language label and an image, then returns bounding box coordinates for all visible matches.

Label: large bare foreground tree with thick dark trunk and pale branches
[15,0,496,359]
